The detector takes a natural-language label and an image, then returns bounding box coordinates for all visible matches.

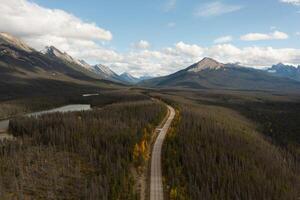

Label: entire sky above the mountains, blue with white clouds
[0,0,300,76]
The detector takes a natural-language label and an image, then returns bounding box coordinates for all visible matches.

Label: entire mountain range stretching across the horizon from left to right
[0,33,300,93]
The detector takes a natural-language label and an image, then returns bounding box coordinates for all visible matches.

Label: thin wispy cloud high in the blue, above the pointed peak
[194,1,242,17]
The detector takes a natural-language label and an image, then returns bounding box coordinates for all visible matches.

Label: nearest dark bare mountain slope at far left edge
[0,33,121,98]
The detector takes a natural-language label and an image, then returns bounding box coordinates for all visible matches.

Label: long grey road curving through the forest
[150,106,175,200]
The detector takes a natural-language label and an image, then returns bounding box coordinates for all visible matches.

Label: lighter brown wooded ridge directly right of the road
[163,101,300,200]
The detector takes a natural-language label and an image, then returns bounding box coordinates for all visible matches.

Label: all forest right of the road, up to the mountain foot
[158,92,300,200]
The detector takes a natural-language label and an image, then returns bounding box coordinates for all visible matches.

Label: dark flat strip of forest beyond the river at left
[0,89,149,120]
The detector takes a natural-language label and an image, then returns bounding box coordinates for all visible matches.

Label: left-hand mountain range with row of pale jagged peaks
[0,33,146,89]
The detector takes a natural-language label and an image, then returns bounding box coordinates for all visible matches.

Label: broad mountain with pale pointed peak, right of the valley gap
[140,58,300,91]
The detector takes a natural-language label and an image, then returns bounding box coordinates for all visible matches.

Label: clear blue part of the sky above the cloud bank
[34,0,300,51]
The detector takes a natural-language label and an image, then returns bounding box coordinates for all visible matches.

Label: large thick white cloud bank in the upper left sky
[0,0,122,70]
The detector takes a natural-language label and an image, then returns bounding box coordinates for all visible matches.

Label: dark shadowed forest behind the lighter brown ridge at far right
[193,91,300,163]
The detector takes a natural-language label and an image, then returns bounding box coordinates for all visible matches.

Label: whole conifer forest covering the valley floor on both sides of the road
[0,89,300,200]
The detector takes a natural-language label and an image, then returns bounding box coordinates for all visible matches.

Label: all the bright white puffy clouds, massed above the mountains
[0,0,300,76]
